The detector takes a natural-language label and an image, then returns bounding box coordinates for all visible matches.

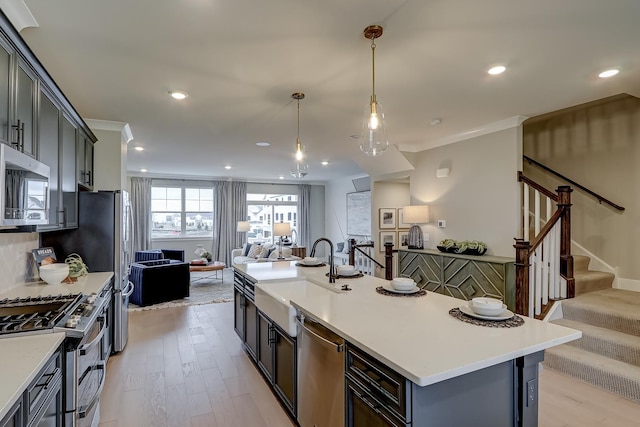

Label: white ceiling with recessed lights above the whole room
[13,0,640,182]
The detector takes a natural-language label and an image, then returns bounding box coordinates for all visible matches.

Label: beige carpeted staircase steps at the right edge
[544,288,640,403]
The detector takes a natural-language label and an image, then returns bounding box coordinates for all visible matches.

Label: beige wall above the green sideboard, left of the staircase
[410,127,522,257]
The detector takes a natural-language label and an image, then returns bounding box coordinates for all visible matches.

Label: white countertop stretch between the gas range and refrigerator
[0,272,113,300]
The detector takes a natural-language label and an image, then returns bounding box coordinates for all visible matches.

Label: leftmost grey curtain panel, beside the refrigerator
[131,177,151,253]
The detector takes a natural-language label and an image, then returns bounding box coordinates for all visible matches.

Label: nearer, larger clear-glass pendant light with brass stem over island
[359,25,389,156]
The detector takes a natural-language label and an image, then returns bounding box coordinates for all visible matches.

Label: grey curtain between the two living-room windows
[211,181,247,265]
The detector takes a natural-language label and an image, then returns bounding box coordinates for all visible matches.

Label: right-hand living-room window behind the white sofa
[247,193,298,243]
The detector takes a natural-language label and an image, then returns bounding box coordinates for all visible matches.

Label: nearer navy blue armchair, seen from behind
[129,259,191,306]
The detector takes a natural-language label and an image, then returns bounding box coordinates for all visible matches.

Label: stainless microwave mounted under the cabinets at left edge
[0,143,49,226]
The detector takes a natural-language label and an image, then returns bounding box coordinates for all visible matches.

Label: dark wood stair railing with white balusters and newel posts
[514,172,575,318]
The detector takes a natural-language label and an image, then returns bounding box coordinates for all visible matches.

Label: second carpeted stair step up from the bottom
[551,319,640,366]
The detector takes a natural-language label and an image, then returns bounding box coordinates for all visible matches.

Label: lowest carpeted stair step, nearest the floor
[544,344,640,402]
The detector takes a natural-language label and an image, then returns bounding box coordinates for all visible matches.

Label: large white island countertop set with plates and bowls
[239,263,581,386]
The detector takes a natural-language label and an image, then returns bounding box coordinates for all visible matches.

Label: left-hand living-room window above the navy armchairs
[151,186,213,239]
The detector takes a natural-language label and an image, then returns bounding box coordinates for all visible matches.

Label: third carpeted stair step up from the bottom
[562,289,640,336]
